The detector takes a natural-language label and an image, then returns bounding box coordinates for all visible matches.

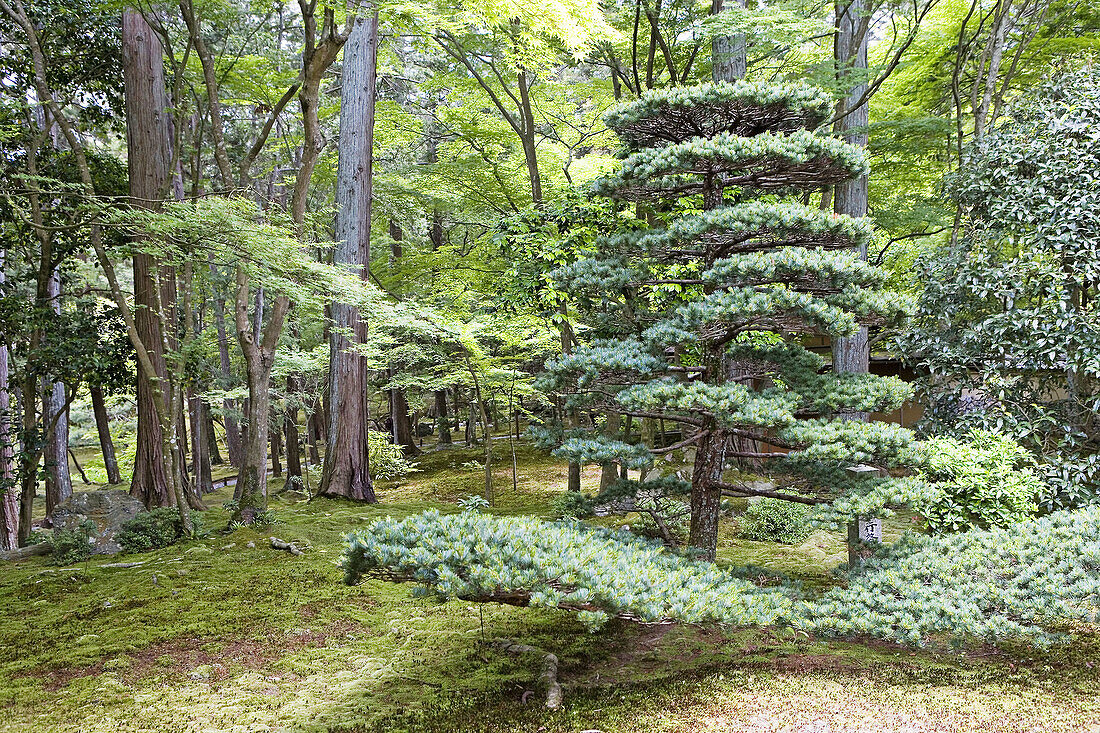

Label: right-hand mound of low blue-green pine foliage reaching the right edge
[814,507,1100,645]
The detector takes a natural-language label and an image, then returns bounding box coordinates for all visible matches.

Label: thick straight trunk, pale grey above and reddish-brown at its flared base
[319,11,378,502]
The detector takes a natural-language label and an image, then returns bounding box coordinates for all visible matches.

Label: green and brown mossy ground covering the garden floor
[0,444,1100,733]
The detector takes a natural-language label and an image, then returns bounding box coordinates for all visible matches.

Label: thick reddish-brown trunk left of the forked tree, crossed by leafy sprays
[122,10,175,507]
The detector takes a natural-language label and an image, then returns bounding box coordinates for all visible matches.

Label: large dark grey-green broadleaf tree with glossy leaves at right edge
[899,65,1100,510]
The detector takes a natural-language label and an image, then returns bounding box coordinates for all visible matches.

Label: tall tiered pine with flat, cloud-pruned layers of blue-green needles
[543,81,919,558]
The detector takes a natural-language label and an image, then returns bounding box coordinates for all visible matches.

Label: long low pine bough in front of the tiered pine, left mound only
[341,511,795,630]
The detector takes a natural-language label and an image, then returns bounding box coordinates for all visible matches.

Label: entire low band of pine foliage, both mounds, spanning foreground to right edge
[341,507,1100,646]
